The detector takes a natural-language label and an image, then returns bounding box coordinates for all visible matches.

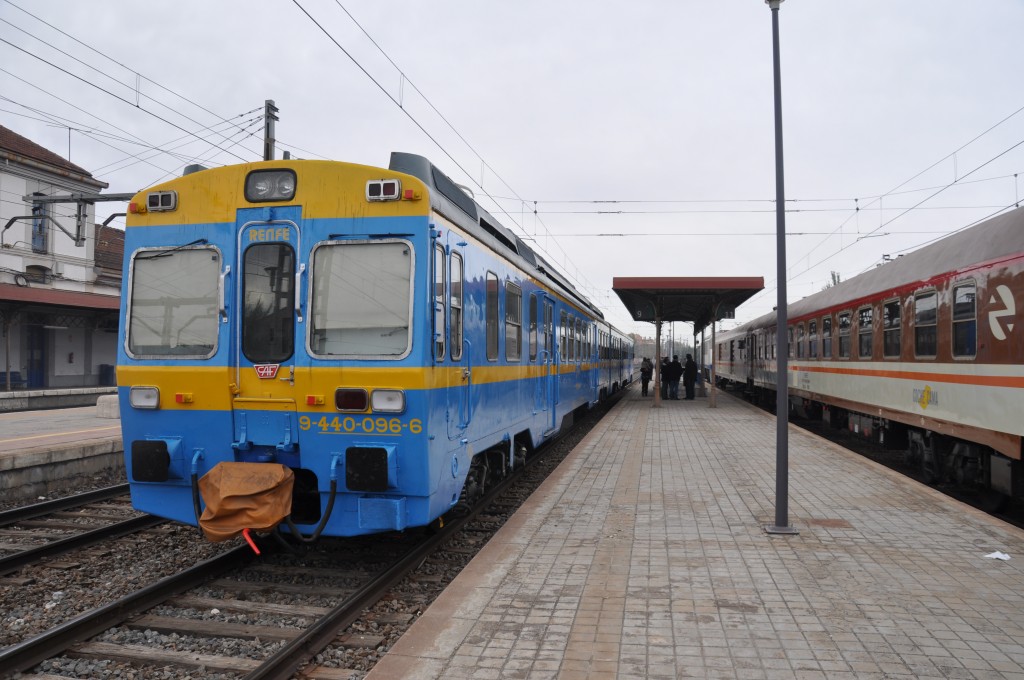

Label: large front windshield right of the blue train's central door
[310,242,413,358]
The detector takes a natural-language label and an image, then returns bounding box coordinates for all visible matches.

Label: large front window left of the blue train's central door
[128,248,220,356]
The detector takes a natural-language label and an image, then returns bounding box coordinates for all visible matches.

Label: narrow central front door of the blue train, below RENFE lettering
[230,216,304,464]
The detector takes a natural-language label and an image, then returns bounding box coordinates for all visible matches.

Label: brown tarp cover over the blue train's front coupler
[199,463,295,543]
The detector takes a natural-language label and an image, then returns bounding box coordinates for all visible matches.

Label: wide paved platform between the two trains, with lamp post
[368,388,1024,680]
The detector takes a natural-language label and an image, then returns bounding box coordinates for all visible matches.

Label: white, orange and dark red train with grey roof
[715,208,1024,496]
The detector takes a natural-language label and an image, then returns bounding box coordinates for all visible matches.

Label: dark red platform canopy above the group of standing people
[611,277,765,332]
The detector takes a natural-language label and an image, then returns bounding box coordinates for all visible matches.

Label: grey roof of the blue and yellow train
[388,152,604,320]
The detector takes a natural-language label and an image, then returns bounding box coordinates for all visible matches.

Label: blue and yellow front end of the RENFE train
[118,161,465,540]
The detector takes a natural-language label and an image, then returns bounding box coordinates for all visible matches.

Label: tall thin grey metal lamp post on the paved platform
[764,0,799,534]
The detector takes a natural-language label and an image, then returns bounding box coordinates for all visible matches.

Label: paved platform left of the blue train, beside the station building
[0,403,124,500]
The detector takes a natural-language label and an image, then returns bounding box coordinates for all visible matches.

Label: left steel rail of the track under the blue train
[0,544,253,678]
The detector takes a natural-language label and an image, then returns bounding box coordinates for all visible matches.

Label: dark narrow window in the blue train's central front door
[242,243,295,363]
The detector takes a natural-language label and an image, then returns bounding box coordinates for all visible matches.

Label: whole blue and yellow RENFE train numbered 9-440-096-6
[117,154,633,541]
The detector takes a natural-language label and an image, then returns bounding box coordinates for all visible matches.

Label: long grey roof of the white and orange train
[737,208,1024,330]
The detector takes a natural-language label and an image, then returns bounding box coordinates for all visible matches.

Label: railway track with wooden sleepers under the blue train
[0,391,622,680]
